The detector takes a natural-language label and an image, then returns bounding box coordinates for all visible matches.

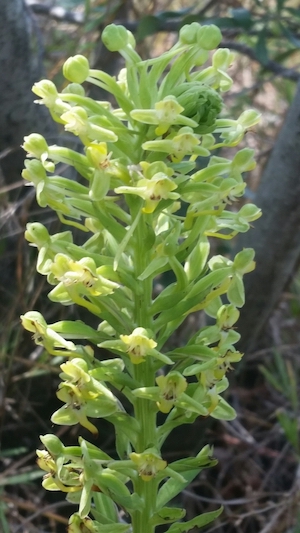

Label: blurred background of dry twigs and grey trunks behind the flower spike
[0,0,300,533]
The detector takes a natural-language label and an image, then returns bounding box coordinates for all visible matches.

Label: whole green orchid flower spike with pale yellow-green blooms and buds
[21,22,261,533]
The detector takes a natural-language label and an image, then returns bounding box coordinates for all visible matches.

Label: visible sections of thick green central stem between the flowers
[132,217,158,533]
